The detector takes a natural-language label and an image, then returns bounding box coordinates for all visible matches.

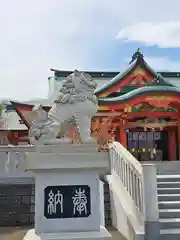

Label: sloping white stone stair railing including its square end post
[109,142,159,225]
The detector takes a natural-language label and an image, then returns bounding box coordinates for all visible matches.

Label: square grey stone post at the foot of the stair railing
[142,164,160,240]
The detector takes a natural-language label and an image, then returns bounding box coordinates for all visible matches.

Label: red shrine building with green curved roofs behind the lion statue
[8,50,180,161]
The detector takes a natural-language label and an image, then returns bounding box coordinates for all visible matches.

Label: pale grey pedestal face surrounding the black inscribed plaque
[35,171,103,233]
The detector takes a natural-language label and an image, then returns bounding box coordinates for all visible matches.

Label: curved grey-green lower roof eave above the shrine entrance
[98,86,180,105]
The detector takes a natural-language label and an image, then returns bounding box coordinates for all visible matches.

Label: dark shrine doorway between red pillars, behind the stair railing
[127,128,169,161]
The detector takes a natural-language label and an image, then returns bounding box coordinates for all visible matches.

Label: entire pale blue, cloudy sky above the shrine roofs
[0,0,180,100]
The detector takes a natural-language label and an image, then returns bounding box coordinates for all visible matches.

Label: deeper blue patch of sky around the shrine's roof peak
[92,42,180,71]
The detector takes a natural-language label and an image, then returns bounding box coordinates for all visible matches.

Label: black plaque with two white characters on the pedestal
[44,185,91,219]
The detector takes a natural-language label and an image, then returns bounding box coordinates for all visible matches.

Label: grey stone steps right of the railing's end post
[157,174,180,240]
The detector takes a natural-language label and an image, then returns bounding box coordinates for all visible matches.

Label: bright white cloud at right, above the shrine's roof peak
[117,21,180,48]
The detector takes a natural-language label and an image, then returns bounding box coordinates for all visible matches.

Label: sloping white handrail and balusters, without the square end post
[110,142,144,216]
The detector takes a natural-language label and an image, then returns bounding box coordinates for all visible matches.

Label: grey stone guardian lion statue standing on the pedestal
[29,70,98,144]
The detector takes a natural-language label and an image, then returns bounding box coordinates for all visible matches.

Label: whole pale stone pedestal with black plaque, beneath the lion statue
[24,144,110,240]
